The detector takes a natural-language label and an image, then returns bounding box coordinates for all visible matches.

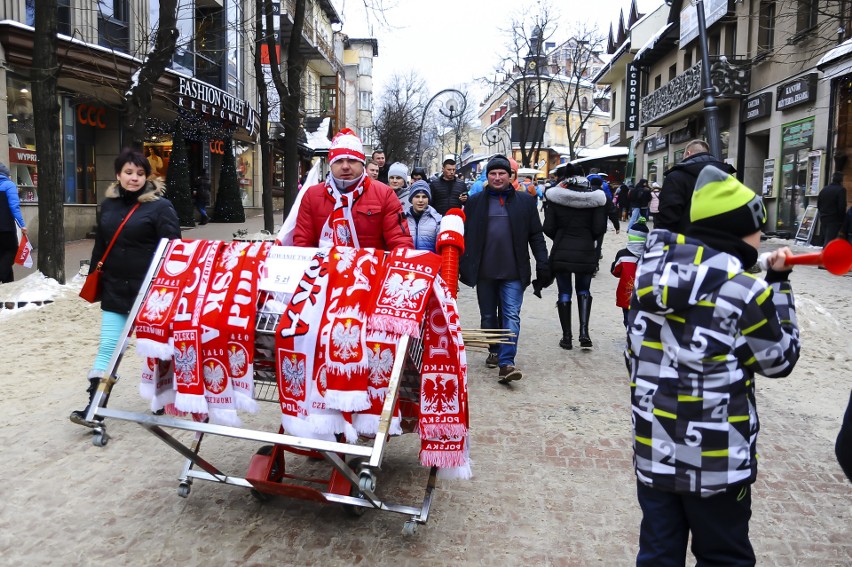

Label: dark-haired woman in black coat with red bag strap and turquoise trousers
[71,149,180,427]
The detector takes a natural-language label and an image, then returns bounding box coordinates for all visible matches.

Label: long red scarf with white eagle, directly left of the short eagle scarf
[318,246,384,412]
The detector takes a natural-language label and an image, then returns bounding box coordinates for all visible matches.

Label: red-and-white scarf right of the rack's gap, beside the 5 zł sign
[275,250,336,439]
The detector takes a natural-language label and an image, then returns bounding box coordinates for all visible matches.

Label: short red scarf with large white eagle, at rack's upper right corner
[369,248,441,337]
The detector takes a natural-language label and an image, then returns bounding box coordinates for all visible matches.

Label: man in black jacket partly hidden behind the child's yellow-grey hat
[654,140,735,234]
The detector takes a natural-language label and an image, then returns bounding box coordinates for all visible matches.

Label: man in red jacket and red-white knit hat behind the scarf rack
[293,132,414,250]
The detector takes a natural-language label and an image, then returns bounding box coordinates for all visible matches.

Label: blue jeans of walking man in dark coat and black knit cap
[476,280,524,366]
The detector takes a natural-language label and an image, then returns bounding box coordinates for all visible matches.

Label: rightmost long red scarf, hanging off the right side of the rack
[418,278,472,479]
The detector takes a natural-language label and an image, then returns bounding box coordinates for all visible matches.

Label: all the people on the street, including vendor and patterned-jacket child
[0,126,852,566]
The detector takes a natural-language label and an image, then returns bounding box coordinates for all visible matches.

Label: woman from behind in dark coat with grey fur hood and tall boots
[544,177,607,350]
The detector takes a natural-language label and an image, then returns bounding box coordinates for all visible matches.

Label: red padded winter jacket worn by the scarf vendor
[293,177,414,250]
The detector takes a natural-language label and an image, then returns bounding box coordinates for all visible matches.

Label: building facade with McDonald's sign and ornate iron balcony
[595,0,852,236]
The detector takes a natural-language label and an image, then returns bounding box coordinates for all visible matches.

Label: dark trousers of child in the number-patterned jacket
[636,482,756,567]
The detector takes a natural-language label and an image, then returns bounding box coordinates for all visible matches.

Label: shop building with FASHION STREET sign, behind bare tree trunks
[0,0,376,240]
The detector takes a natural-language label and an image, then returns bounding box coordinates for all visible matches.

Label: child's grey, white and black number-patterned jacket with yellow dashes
[625,230,799,496]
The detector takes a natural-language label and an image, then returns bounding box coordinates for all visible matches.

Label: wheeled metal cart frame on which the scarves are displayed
[87,240,466,535]
